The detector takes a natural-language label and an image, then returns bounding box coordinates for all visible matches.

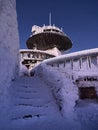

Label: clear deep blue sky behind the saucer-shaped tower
[16,0,98,52]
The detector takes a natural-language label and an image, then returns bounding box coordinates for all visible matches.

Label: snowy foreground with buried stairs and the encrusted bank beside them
[0,64,98,130]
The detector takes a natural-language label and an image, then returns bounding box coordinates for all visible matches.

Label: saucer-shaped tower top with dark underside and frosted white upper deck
[26,25,72,51]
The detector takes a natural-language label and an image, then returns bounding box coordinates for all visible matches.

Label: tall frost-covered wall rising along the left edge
[0,0,19,95]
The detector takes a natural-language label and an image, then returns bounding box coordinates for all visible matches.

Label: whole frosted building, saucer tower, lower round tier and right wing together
[20,25,98,99]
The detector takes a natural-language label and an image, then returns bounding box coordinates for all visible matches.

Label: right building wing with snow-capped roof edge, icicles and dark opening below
[44,48,98,99]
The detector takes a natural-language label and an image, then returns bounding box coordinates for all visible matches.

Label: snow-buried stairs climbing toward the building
[9,77,60,121]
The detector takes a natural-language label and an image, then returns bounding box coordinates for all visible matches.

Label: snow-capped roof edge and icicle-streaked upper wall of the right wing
[44,48,98,76]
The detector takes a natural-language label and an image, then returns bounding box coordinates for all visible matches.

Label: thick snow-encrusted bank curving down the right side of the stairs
[35,63,79,120]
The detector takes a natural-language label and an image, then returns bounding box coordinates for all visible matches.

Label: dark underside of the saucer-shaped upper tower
[26,32,72,51]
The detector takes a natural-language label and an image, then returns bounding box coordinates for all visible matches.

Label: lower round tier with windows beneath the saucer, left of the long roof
[20,49,55,69]
